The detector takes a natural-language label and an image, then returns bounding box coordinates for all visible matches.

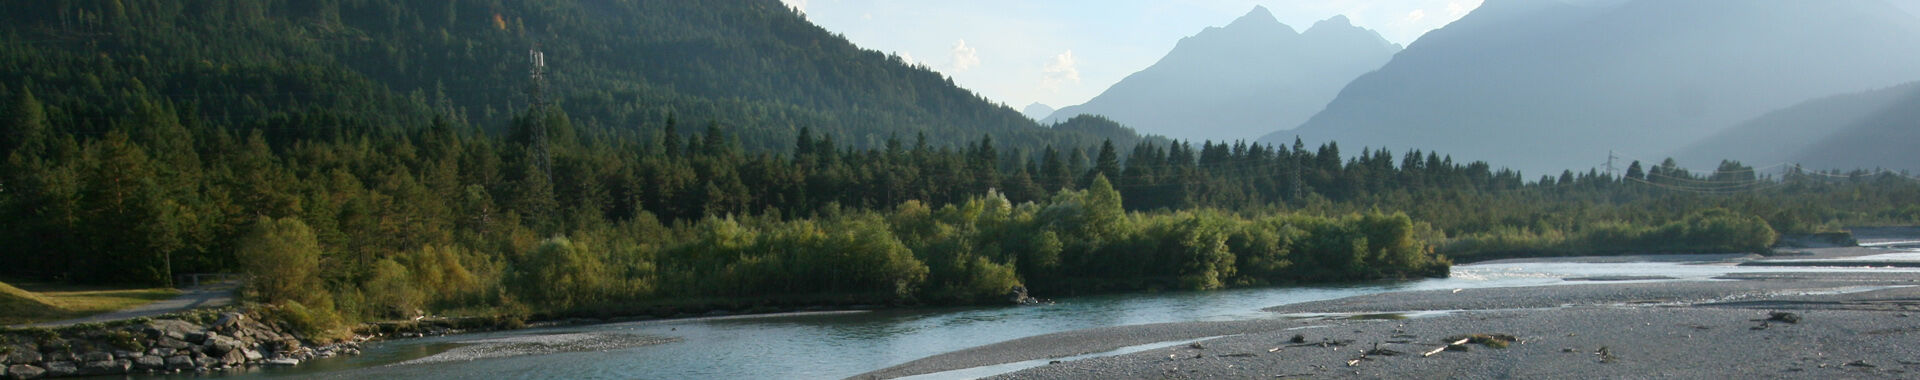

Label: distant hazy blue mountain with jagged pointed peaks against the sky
[1048,8,1400,140]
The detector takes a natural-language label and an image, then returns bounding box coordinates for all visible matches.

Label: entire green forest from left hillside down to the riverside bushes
[0,0,1920,340]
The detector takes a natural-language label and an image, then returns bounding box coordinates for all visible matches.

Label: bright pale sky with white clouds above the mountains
[781,0,1482,109]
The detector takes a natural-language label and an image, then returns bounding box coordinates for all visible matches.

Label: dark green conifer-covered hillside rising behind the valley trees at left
[0,0,1137,152]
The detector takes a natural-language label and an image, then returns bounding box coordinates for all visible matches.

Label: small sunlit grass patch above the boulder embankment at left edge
[0,282,180,324]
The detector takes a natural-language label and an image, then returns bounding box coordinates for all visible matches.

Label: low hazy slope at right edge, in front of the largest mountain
[1670,83,1920,169]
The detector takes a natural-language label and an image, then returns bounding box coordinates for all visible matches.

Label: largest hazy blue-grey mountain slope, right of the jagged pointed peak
[1265,0,1920,173]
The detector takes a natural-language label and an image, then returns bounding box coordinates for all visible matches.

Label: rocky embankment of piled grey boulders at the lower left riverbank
[0,311,359,378]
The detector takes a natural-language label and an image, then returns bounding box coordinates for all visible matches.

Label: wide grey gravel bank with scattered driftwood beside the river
[854,248,1920,378]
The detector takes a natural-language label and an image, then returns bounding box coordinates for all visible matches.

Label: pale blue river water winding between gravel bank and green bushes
[176,251,1885,380]
